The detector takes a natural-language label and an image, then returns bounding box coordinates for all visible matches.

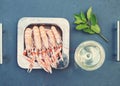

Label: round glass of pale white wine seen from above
[74,40,105,71]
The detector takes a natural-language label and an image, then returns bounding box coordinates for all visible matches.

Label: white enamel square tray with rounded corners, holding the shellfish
[17,17,70,69]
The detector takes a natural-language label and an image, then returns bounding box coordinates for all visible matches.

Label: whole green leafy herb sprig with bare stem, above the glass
[74,7,108,42]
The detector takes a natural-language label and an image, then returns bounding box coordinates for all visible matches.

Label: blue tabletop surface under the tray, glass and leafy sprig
[0,0,120,86]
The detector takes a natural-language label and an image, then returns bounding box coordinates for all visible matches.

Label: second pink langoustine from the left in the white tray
[33,26,52,73]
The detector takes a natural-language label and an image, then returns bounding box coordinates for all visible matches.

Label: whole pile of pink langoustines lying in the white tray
[23,25,63,73]
